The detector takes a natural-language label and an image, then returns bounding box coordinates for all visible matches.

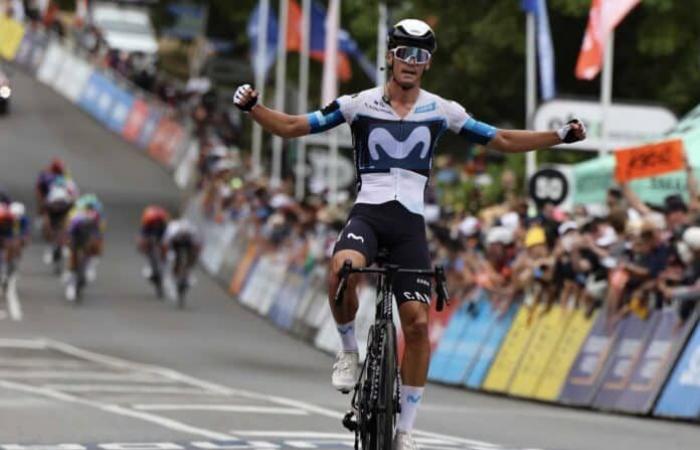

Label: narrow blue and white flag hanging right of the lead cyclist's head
[522,0,556,100]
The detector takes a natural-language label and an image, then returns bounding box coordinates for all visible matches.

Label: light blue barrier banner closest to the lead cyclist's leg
[443,291,494,384]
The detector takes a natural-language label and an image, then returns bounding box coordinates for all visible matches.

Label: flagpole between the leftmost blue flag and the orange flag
[270,0,289,188]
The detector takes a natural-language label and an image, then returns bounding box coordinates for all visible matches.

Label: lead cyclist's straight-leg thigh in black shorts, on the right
[389,225,432,306]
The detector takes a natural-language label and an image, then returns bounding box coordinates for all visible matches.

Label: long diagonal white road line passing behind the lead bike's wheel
[31,338,499,449]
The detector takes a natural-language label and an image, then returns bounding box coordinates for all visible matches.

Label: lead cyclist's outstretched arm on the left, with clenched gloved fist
[233,84,345,138]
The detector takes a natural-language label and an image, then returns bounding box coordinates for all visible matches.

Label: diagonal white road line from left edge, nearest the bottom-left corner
[0,380,238,441]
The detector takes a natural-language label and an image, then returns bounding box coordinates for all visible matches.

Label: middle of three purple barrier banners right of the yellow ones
[593,311,659,410]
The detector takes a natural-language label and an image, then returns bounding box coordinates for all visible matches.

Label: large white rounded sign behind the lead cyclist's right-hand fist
[534,100,678,151]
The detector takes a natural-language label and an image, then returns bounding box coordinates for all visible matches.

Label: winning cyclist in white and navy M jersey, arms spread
[233,19,585,449]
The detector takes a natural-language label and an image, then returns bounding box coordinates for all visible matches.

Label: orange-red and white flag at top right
[576,0,639,80]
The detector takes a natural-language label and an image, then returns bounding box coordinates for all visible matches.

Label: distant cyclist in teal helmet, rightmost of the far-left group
[66,209,100,301]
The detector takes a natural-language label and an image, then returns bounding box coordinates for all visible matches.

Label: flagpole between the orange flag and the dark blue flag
[294,0,311,200]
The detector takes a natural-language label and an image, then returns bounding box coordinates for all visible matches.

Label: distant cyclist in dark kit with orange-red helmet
[138,205,170,292]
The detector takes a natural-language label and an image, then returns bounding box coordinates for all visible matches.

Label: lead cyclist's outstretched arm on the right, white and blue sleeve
[445,97,586,153]
